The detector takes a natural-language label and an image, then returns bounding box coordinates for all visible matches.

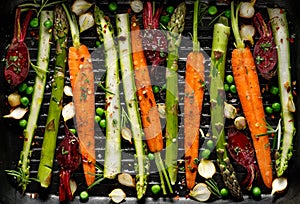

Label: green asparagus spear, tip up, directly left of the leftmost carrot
[37,5,69,188]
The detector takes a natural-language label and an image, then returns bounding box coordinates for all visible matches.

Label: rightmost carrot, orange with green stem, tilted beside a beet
[231,2,273,188]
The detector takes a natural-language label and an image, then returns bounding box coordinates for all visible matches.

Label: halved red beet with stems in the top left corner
[4,8,33,87]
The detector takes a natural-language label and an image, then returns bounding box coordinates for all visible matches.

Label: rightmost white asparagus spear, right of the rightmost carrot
[267,8,296,177]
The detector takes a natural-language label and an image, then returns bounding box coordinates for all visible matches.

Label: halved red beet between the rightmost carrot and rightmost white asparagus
[253,13,277,80]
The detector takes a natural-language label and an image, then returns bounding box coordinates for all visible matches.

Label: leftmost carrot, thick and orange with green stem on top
[62,4,96,186]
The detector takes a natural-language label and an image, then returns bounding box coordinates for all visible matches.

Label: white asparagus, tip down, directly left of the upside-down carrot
[116,13,150,200]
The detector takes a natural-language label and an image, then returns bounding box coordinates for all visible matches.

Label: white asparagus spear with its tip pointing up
[94,6,121,178]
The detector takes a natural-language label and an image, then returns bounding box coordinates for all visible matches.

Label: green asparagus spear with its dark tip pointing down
[209,17,243,200]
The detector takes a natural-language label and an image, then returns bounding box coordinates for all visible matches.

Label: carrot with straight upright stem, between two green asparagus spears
[184,0,205,189]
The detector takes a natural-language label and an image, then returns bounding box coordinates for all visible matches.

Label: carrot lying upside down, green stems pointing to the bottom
[130,15,173,194]
